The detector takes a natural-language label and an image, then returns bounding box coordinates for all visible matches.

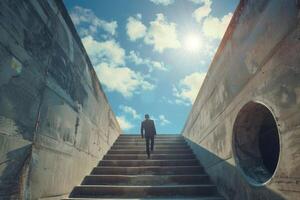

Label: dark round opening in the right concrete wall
[233,102,280,185]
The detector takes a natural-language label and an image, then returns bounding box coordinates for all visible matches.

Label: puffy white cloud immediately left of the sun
[144,13,181,53]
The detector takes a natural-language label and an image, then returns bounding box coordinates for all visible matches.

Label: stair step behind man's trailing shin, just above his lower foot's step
[107,148,193,155]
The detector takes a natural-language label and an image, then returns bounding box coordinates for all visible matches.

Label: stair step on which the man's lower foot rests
[103,154,195,160]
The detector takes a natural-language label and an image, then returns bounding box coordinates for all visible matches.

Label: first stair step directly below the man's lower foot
[98,159,199,167]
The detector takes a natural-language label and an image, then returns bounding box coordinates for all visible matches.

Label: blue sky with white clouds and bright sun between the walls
[64,0,239,134]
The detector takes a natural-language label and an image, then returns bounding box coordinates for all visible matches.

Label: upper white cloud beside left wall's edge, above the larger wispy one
[82,36,125,65]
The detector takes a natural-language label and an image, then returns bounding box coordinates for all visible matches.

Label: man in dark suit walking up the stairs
[141,114,156,159]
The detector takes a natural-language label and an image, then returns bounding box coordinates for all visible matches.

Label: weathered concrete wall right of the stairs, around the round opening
[182,0,300,200]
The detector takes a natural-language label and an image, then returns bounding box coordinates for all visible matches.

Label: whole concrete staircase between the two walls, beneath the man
[68,135,224,200]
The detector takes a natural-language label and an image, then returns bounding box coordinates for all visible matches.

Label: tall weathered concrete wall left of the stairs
[0,0,121,199]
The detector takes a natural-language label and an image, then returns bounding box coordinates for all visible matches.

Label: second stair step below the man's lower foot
[91,166,204,175]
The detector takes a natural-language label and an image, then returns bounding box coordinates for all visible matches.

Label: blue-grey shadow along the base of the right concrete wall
[185,138,286,200]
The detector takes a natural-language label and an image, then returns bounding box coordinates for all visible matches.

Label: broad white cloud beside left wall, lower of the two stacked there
[95,63,154,97]
